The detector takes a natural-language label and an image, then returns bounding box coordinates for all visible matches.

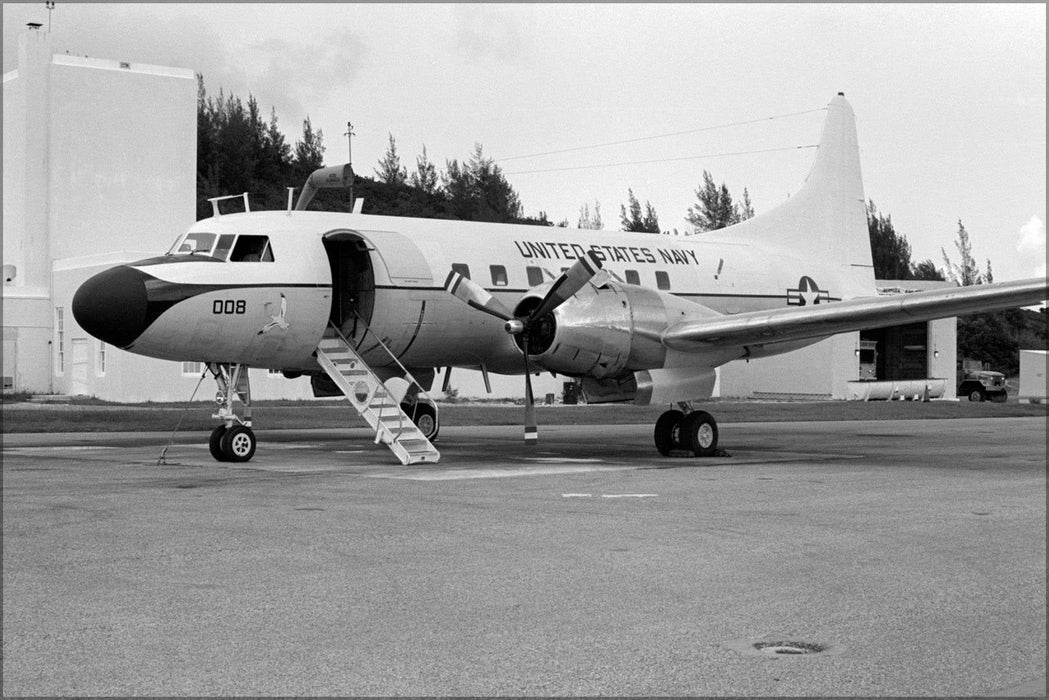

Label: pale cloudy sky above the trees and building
[3,2,1046,281]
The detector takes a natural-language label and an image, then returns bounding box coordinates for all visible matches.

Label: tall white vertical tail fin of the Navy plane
[730,92,876,298]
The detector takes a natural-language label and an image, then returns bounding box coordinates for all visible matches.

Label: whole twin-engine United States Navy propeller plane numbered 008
[72,93,1049,464]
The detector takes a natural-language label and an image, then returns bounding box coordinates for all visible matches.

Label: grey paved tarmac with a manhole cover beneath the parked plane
[2,419,1046,697]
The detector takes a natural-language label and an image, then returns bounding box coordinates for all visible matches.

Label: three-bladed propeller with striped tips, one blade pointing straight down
[445,251,601,445]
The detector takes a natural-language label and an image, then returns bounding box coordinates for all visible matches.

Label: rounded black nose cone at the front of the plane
[72,266,148,347]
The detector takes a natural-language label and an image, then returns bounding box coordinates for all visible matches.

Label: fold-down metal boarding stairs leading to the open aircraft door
[317,325,441,465]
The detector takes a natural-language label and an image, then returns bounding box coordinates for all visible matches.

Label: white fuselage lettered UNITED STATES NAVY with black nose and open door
[73,211,839,374]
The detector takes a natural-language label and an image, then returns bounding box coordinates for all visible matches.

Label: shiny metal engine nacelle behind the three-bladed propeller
[514,281,716,379]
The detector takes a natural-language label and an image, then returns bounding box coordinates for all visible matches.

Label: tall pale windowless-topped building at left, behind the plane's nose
[3,25,312,401]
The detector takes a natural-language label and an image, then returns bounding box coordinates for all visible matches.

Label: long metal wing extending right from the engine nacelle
[661,277,1049,352]
